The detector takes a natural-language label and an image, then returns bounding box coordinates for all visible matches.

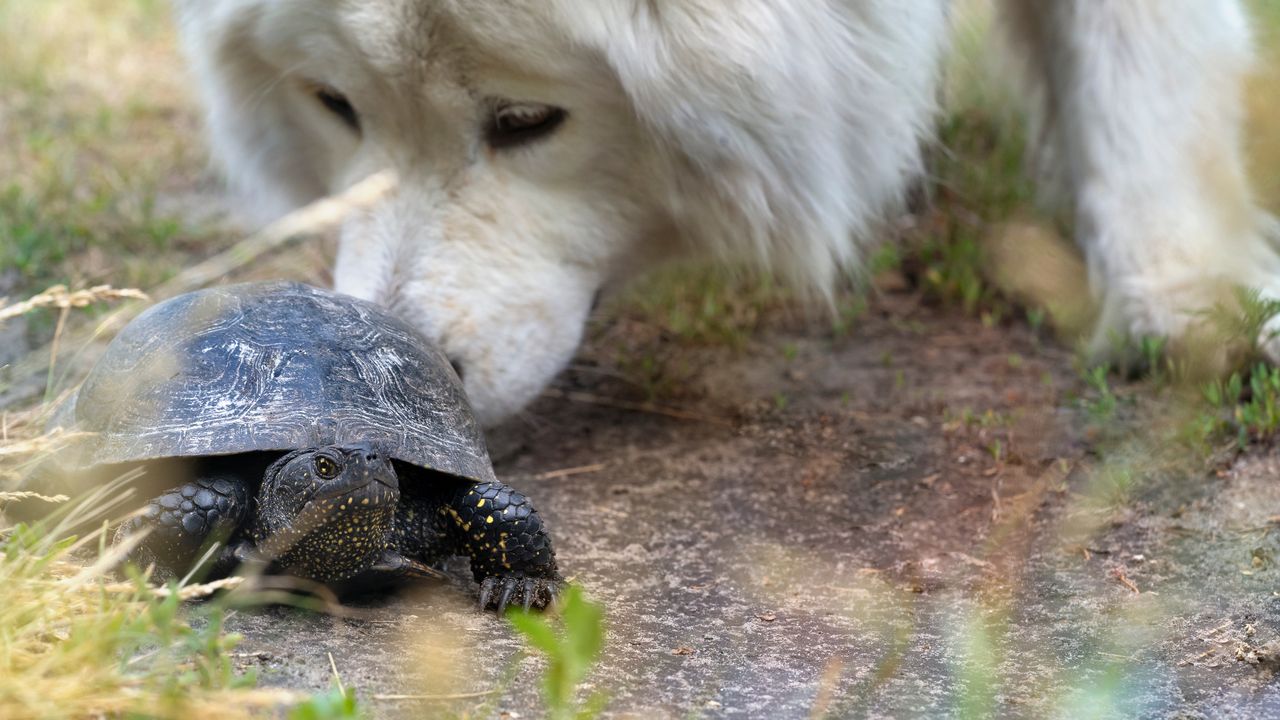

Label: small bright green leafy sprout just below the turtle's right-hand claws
[507,585,608,720]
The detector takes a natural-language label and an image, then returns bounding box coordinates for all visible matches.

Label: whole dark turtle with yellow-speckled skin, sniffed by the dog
[58,282,563,612]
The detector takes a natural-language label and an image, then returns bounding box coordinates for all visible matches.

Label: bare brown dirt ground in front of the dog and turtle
[209,288,1280,717]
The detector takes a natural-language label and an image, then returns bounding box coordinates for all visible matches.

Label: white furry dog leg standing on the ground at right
[1005,0,1280,369]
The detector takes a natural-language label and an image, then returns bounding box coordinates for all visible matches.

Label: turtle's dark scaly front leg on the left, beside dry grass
[114,474,250,582]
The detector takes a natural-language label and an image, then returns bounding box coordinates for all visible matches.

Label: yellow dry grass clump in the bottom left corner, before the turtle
[0,492,306,720]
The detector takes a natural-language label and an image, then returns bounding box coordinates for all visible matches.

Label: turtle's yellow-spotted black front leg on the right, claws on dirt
[439,483,564,614]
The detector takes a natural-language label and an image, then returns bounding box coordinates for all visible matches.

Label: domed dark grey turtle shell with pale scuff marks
[67,282,494,482]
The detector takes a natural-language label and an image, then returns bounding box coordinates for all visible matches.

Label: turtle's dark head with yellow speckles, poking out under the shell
[253,445,399,582]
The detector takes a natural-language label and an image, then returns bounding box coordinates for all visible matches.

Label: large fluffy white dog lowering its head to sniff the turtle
[179,0,1280,423]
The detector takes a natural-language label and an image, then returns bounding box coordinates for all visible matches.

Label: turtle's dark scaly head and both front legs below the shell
[116,445,562,612]
